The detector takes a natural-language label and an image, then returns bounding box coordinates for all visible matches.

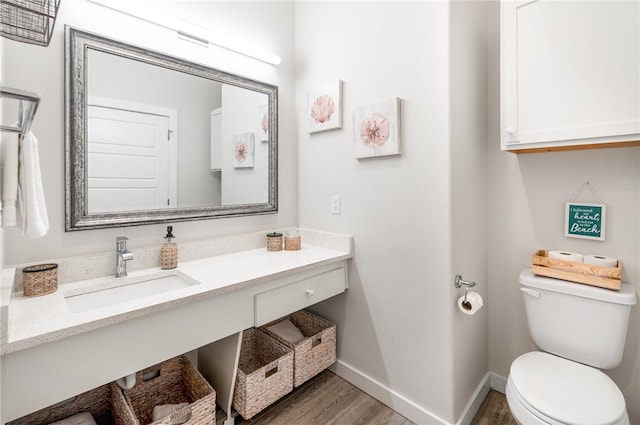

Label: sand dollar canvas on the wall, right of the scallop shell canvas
[353,98,401,158]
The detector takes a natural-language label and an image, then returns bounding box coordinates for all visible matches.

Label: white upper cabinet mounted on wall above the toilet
[500,0,640,151]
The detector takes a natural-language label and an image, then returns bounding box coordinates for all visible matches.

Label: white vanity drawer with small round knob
[255,267,347,326]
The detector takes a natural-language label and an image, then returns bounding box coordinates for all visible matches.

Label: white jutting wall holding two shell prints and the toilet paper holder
[295,1,488,423]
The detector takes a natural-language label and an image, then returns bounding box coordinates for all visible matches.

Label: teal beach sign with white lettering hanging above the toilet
[564,202,607,241]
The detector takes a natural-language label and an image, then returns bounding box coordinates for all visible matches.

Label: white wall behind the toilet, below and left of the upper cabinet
[487,2,640,424]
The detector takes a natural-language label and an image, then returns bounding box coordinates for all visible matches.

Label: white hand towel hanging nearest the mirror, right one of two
[18,132,49,238]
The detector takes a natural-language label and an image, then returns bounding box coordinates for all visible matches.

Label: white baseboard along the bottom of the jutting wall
[330,360,507,425]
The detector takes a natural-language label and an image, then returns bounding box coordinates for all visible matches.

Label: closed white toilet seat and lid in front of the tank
[507,351,628,425]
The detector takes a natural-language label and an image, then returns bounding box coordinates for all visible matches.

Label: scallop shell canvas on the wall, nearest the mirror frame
[307,80,342,133]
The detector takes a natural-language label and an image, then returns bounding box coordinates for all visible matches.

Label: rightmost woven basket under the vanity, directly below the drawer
[260,310,336,387]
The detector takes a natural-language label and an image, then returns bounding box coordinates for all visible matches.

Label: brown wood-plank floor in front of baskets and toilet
[236,370,517,425]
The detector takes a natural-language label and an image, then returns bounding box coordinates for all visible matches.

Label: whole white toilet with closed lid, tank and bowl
[506,269,636,425]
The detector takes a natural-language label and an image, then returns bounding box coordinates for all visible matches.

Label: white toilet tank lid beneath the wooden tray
[520,268,636,305]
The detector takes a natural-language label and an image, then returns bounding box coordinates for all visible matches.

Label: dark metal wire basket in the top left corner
[0,0,60,46]
